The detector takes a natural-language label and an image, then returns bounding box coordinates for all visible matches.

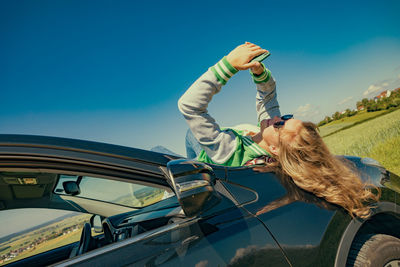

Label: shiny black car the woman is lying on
[0,135,400,267]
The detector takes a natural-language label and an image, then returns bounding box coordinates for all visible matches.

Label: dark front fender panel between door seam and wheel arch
[225,167,340,266]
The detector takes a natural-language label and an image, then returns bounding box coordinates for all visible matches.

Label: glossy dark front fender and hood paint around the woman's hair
[223,160,400,266]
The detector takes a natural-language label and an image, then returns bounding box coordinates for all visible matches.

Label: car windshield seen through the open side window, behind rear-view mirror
[54,175,173,208]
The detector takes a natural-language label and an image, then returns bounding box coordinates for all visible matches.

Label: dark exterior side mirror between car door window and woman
[167,159,221,217]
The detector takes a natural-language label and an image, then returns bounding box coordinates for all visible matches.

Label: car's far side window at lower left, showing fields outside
[0,209,91,265]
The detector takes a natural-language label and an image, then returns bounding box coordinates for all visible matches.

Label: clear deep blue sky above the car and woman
[0,0,400,157]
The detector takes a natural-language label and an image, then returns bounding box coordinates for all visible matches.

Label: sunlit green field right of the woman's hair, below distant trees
[320,109,400,174]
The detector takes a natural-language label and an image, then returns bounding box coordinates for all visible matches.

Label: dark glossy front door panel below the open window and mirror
[57,201,289,266]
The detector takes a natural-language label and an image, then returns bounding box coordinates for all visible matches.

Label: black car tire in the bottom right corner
[347,234,400,267]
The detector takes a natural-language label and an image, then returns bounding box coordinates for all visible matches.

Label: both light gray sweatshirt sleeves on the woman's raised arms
[178,57,280,164]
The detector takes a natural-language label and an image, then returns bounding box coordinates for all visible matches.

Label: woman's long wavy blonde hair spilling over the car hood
[277,122,380,218]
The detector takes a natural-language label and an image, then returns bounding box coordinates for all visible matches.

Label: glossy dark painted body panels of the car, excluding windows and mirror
[0,135,400,266]
